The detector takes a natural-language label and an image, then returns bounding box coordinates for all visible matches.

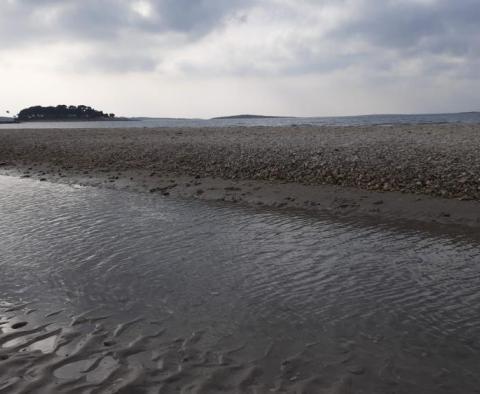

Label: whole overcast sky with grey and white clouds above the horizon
[0,0,480,118]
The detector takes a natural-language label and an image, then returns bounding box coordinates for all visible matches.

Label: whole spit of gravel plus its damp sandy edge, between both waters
[0,124,480,228]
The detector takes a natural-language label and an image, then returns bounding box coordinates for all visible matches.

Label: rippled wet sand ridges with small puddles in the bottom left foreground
[0,306,365,394]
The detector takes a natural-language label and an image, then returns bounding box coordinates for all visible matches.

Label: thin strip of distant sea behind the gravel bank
[0,112,480,129]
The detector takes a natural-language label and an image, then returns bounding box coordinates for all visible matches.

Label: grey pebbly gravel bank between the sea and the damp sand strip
[0,125,480,200]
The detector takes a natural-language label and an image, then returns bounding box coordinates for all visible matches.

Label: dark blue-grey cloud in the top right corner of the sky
[331,0,480,54]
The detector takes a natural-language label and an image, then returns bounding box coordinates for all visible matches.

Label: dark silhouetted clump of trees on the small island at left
[17,105,115,122]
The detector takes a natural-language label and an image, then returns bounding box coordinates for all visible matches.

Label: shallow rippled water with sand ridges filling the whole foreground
[0,177,480,393]
